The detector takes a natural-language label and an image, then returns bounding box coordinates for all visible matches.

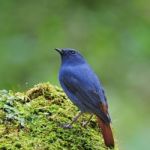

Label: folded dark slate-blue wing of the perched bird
[61,74,110,123]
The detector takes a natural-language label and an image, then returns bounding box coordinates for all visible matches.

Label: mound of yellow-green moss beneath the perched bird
[0,83,118,150]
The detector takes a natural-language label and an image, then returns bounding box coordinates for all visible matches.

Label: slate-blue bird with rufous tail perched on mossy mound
[55,48,114,148]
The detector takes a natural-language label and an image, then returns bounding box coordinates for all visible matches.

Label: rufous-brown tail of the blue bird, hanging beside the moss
[97,117,114,148]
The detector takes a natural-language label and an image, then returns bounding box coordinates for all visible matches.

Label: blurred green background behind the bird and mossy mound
[0,0,150,150]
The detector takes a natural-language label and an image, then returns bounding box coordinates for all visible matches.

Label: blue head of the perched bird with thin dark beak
[55,48,85,64]
